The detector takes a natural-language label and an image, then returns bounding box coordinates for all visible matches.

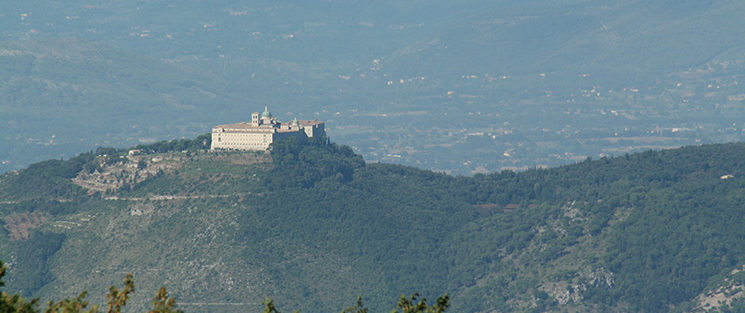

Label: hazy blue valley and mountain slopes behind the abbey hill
[0,0,745,175]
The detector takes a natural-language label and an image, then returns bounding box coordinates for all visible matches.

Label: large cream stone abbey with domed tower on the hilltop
[210,107,326,150]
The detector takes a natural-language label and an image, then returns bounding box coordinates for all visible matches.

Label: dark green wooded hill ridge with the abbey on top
[0,136,745,312]
